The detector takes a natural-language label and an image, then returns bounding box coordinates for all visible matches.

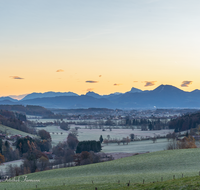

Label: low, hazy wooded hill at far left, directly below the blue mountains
[0,105,54,117]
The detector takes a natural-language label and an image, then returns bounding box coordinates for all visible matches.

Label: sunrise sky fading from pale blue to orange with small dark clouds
[0,0,200,96]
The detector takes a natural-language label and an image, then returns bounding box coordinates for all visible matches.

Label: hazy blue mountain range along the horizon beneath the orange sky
[0,85,200,109]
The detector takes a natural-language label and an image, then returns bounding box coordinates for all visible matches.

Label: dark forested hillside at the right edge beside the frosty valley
[169,112,200,132]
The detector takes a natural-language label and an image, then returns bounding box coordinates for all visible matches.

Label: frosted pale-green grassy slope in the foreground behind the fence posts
[1,149,200,190]
